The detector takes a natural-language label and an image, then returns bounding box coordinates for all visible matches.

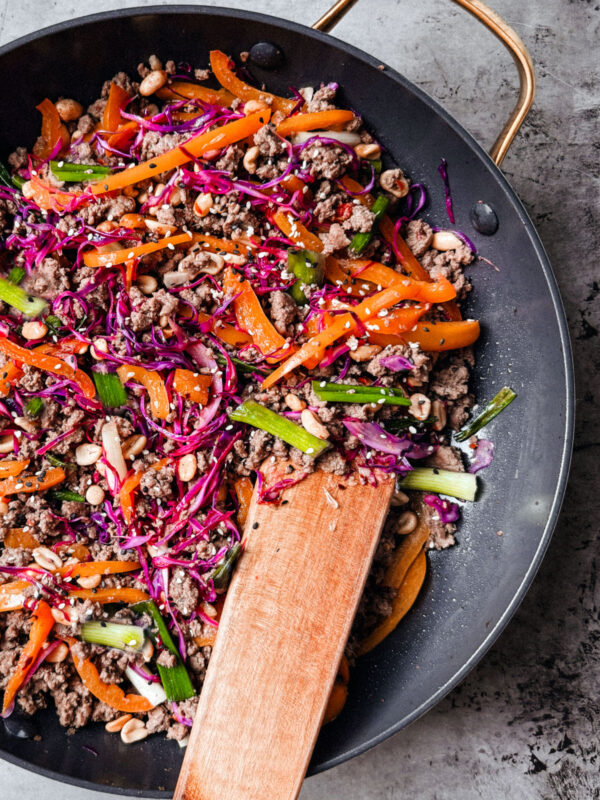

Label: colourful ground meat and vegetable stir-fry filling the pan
[0,51,512,742]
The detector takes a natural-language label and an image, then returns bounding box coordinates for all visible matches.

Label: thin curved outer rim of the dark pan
[0,4,575,798]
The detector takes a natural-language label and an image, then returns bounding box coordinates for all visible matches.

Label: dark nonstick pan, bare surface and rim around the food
[0,6,573,797]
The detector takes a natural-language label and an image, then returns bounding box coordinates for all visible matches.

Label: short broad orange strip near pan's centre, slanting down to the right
[223,267,292,364]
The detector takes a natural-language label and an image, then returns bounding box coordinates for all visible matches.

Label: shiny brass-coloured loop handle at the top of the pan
[312,0,535,166]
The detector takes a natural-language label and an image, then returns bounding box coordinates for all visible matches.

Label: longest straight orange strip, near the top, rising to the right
[90,109,271,194]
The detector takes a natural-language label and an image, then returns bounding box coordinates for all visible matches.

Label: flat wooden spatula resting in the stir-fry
[175,472,394,800]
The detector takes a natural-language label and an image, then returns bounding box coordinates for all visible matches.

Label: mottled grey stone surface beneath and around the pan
[0,0,600,800]
